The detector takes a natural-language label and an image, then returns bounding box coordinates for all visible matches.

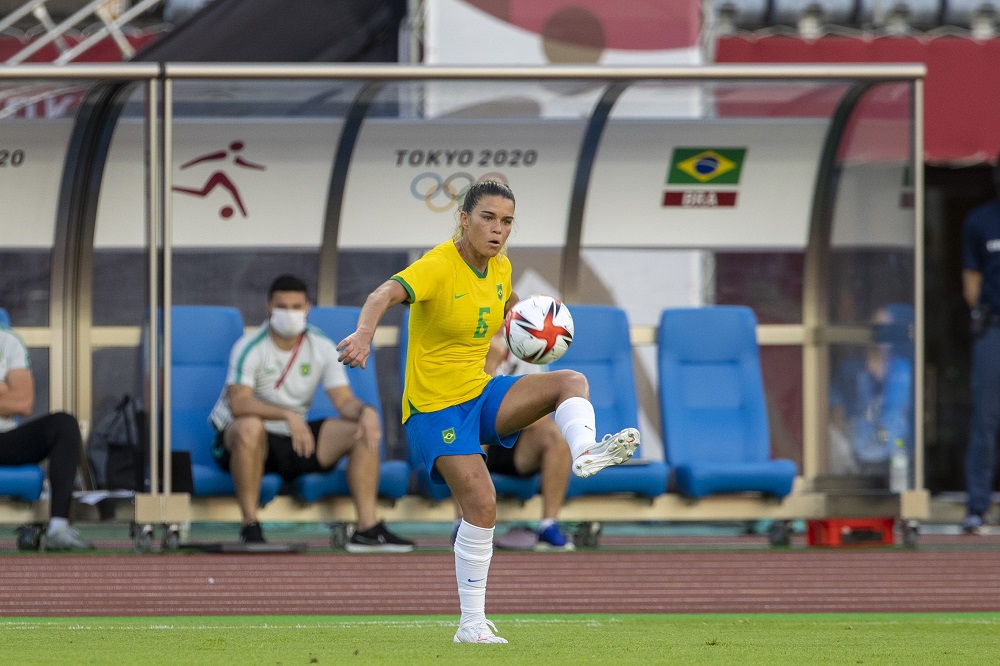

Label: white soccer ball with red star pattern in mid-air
[503,295,573,365]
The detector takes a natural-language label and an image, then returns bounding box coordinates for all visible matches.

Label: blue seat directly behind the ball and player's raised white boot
[549,305,669,498]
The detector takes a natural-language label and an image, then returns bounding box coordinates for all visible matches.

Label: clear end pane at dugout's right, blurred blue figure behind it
[827,83,916,480]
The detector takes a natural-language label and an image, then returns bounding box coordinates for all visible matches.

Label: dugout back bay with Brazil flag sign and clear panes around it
[579,80,864,470]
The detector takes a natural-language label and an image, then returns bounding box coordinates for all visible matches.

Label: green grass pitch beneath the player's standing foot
[0,613,1000,666]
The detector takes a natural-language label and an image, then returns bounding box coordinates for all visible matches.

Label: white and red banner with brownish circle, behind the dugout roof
[422,0,703,117]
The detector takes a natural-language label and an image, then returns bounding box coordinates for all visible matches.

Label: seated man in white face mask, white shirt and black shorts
[210,275,413,552]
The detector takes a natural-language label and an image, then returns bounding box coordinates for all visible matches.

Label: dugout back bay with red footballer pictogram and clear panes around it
[164,80,362,325]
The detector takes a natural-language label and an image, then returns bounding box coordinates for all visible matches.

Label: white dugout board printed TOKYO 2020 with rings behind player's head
[340,120,585,248]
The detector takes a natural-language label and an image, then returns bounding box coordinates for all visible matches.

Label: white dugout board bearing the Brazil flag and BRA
[583,119,827,249]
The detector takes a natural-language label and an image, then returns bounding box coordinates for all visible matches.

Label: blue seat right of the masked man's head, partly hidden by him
[292,306,410,502]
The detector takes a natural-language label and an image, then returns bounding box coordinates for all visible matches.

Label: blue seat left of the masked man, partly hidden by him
[170,305,282,506]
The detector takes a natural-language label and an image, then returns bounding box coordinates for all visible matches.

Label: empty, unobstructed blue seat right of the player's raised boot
[657,306,796,498]
